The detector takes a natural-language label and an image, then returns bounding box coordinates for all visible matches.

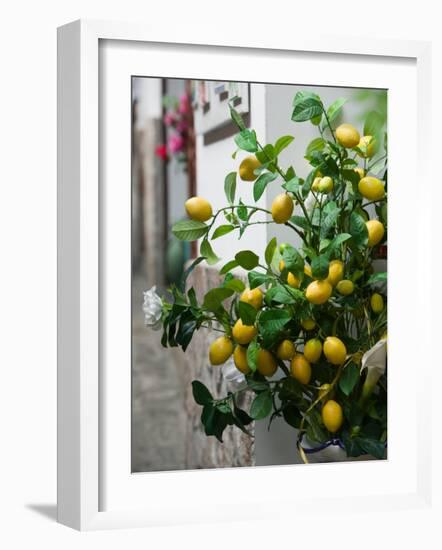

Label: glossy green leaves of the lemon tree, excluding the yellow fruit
[161,91,388,464]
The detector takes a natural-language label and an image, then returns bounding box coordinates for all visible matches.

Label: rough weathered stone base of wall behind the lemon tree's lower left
[181,264,255,469]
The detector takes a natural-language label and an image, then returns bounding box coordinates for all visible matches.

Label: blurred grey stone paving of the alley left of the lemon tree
[132,274,186,472]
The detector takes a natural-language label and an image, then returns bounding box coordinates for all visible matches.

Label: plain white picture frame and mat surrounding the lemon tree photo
[58,21,434,532]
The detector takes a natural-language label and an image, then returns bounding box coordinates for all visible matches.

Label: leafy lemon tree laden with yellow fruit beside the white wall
[156,92,388,458]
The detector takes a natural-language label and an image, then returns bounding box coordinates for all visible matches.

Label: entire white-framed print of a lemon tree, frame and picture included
[58,21,432,529]
